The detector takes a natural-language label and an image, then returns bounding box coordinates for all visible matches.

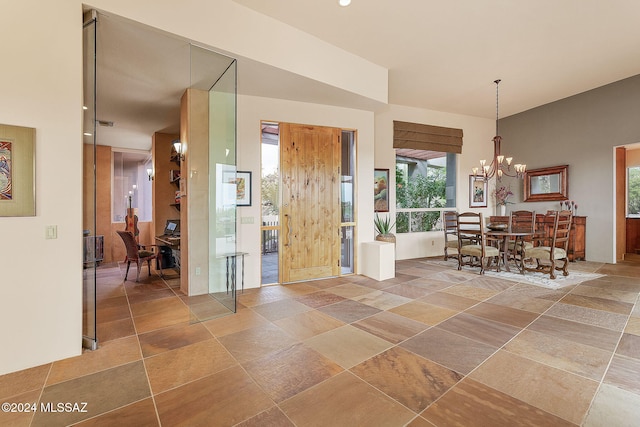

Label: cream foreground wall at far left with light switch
[0,0,82,374]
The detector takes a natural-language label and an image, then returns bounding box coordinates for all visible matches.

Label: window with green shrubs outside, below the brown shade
[396,149,456,233]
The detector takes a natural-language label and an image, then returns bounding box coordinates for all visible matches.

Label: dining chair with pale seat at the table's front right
[522,210,573,279]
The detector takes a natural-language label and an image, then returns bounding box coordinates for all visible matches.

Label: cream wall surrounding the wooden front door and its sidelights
[238,96,374,288]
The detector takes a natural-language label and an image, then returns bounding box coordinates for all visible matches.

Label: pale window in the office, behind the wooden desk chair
[112,150,152,222]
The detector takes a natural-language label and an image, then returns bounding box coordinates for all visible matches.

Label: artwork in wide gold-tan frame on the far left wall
[0,125,36,216]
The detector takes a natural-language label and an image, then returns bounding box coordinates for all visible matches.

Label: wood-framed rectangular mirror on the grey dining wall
[524,165,569,202]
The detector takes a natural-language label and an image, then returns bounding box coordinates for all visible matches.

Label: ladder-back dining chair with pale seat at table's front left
[458,212,500,274]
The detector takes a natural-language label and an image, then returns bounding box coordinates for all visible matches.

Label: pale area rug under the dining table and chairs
[426,260,604,289]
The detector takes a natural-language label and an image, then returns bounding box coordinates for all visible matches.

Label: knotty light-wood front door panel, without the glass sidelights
[280,123,341,283]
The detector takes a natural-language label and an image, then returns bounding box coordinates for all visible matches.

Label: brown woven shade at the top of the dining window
[393,120,462,154]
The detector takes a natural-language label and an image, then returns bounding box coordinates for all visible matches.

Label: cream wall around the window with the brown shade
[372,105,495,259]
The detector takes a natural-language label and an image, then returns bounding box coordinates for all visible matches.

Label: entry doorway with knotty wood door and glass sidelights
[261,122,356,285]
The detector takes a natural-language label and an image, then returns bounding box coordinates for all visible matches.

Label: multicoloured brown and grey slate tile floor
[0,259,640,427]
